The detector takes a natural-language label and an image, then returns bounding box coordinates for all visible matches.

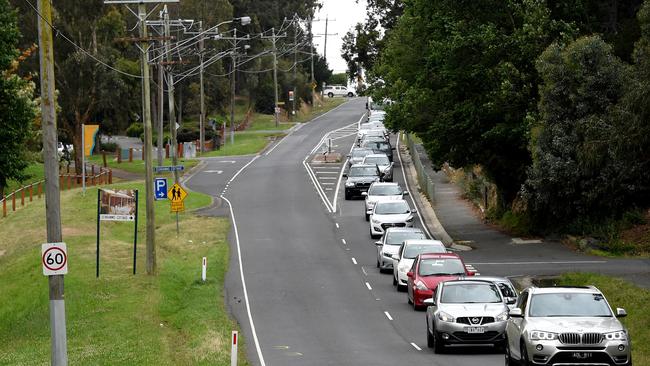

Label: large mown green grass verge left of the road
[0,182,248,365]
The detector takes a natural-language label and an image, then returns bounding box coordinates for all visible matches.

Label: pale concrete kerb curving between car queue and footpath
[398,137,472,251]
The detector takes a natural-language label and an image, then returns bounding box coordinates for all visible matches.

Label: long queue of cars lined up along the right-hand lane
[344,103,632,366]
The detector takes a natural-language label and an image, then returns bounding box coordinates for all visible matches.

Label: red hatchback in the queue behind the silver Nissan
[406,253,475,310]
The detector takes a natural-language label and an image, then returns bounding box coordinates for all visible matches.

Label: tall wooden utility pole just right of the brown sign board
[138,3,156,275]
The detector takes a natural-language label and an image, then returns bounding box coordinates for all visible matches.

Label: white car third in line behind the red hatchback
[370,199,417,239]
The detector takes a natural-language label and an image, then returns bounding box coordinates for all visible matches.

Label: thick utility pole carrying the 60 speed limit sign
[38,0,68,366]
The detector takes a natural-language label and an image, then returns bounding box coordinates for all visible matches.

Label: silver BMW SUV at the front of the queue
[505,286,632,366]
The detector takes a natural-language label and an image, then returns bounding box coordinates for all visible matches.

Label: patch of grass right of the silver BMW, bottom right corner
[559,273,650,365]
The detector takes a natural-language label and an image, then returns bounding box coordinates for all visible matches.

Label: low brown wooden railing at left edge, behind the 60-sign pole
[0,165,113,217]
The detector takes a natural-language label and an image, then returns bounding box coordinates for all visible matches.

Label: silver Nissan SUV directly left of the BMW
[424,280,508,353]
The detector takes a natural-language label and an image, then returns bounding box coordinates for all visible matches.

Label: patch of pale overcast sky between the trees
[312,0,366,73]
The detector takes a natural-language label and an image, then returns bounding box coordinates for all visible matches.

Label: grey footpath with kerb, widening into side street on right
[399,134,650,288]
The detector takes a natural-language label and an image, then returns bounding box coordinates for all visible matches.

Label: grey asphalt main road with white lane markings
[187,99,647,366]
